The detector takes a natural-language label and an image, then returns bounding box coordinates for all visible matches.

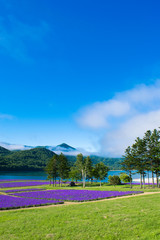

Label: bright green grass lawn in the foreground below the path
[0,193,160,240]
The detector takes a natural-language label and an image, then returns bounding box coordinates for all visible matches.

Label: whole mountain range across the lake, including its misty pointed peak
[0,143,122,171]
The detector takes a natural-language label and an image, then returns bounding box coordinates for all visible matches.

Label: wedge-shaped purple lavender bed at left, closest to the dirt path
[0,195,63,209]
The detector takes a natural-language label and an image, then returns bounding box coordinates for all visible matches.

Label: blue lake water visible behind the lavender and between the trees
[0,170,151,182]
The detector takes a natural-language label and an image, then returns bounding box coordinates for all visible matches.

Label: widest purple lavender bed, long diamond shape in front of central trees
[13,190,141,202]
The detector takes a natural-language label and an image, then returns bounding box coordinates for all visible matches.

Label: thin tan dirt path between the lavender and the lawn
[0,192,160,213]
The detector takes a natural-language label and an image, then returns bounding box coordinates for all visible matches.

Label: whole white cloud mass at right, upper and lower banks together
[77,80,160,156]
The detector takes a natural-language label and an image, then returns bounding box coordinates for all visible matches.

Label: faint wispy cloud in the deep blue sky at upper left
[0,15,49,61]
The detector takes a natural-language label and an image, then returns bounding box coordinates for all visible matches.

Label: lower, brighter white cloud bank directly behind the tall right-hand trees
[100,109,160,157]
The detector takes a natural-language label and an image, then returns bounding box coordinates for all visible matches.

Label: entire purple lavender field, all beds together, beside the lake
[0,180,141,210]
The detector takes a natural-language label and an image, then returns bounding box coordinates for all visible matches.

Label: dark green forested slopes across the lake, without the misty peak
[0,147,122,171]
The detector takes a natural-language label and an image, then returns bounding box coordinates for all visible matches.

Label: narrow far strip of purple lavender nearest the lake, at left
[0,181,49,188]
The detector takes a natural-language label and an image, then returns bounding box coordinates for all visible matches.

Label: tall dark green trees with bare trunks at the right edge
[121,129,160,188]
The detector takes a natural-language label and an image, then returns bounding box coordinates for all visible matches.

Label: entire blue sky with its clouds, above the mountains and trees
[0,0,160,156]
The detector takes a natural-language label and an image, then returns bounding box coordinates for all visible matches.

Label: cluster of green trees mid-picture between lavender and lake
[45,153,109,188]
